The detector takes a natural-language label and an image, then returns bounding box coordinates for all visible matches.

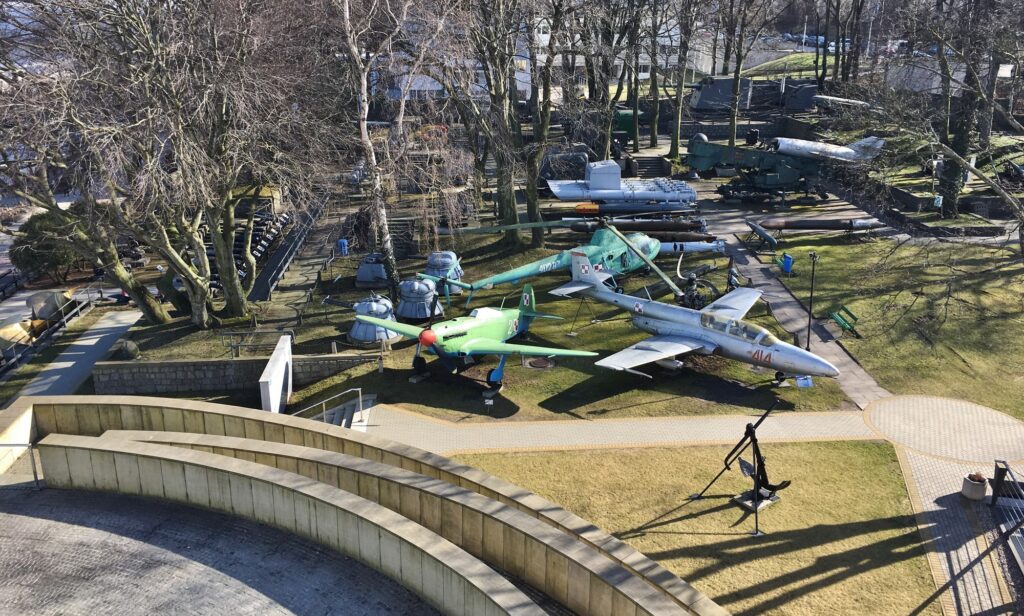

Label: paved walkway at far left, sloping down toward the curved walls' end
[18,310,142,396]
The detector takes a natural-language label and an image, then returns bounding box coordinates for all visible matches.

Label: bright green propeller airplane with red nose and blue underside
[355,284,597,392]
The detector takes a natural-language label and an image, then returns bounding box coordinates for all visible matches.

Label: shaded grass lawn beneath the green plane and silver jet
[292,234,845,421]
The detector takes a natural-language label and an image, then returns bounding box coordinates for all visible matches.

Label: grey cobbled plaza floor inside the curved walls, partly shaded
[0,487,436,616]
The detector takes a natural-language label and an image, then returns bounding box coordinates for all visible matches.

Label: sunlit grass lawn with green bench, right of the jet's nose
[770,235,1024,419]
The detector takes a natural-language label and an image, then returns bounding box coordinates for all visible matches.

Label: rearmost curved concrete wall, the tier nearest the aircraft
[12,396,727,616]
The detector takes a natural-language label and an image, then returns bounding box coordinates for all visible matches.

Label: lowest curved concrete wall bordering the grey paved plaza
[39,434,544,616]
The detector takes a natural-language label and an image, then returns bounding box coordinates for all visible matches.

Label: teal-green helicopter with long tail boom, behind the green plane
[417,225,662,302]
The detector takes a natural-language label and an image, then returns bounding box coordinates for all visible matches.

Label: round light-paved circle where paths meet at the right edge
[865,396,1024,464]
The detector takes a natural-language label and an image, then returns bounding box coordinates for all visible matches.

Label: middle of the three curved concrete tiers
[100,431,683,615]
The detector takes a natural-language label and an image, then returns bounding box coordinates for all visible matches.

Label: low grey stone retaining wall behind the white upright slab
[92,355,375,395]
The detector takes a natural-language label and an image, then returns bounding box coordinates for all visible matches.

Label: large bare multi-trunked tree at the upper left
[0,0,333,327]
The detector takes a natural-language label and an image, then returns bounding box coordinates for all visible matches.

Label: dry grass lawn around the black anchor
[459,442,940,615]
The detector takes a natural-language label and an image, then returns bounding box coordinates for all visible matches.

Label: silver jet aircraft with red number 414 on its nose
[551,251,839,382]
